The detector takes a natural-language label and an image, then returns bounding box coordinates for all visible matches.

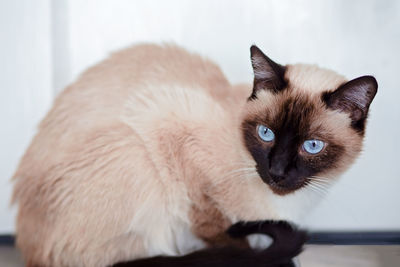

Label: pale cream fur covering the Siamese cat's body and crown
[13,45,360,266]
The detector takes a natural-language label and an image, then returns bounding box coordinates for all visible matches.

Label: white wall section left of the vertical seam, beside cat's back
[0,0,54,234]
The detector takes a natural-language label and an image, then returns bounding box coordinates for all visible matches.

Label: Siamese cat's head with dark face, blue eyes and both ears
[242,46,378,195]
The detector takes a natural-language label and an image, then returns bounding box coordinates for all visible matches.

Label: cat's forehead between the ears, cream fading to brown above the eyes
[246,64,346,131]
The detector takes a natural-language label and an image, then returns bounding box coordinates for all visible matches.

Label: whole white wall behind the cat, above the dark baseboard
[0,0,400,232]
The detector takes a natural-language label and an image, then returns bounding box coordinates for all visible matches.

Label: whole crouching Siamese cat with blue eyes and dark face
[13,45,377,266]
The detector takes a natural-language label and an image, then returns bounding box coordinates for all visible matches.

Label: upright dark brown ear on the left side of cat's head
[250,45,286,99]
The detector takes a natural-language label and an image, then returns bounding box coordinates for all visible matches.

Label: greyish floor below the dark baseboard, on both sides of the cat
[0,245,400,267]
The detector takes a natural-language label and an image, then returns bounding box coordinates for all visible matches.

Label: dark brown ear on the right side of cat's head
[323,76,378,132]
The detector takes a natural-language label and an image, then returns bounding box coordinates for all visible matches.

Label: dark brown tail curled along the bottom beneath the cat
[114,221,307,267]
